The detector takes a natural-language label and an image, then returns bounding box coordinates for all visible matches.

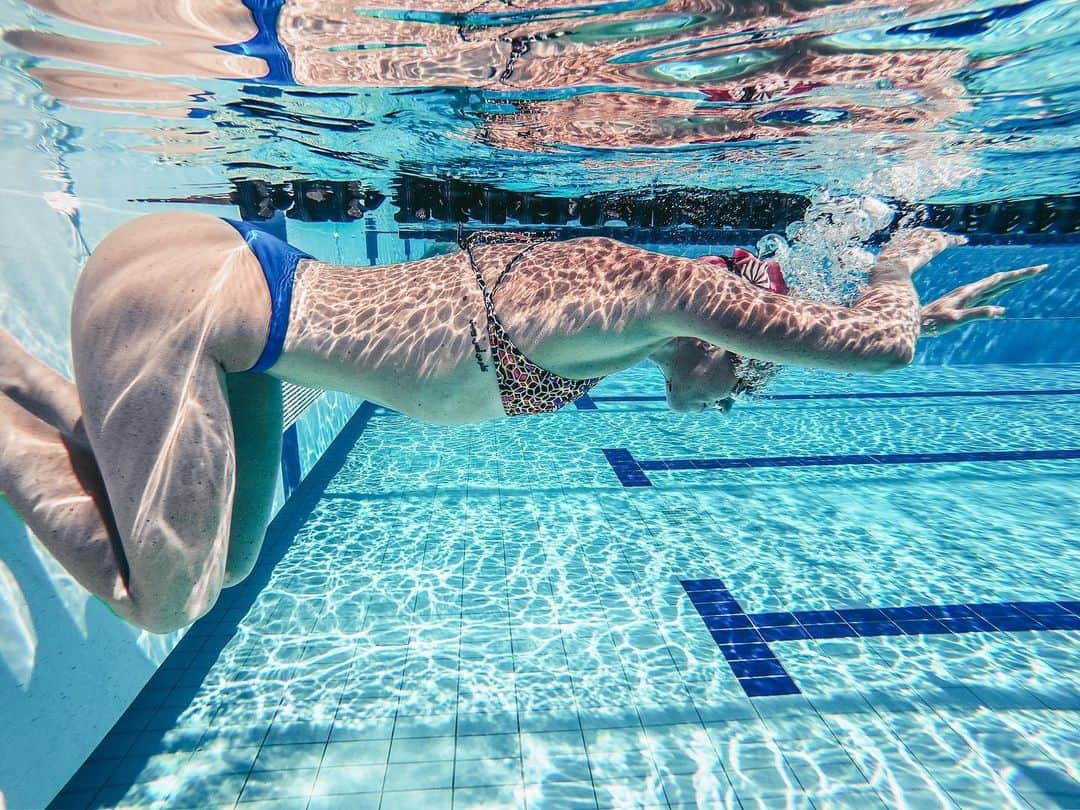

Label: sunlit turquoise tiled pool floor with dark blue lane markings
[53,365,1080,810]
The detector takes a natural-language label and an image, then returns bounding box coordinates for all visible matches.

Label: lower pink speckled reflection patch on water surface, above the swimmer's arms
[477,52,966,151]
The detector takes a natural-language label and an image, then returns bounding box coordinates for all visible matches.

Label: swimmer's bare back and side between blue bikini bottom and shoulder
[272,239,688,423]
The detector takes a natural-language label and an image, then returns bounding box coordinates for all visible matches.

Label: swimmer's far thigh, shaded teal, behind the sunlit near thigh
[225,374,282,588]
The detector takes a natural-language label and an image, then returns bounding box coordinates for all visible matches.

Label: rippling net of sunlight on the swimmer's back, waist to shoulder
[285,239,652,390]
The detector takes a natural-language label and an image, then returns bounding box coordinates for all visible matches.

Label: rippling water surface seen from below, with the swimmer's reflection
[0,0,1080,203]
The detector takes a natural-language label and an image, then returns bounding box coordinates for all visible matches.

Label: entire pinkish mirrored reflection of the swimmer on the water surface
[3,0,966,148]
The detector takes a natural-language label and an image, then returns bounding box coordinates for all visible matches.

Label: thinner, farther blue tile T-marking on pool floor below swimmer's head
[602,448,1080,487]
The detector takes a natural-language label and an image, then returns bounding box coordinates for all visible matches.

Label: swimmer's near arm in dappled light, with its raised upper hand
[657,229,962,373]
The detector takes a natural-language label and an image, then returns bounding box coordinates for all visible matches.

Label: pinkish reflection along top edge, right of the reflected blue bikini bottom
[278,0,963,91]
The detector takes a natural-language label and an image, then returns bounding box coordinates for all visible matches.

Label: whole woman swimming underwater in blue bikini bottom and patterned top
[0,213,1043,633]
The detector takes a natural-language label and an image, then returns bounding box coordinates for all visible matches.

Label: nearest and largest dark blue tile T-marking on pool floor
[681,579,1080,698]
